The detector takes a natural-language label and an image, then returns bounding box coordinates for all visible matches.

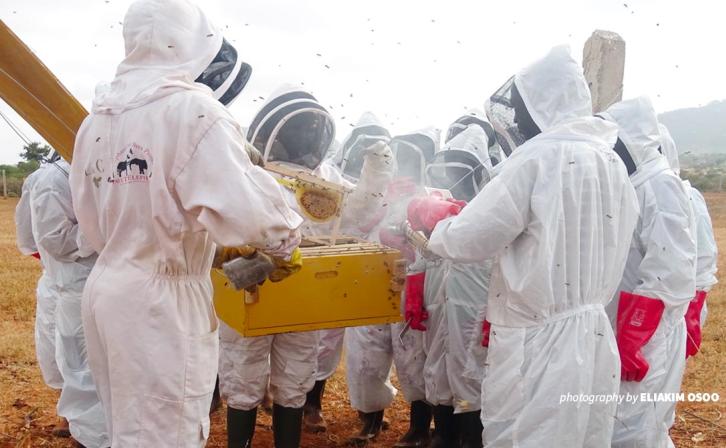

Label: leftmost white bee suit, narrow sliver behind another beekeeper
[15,169,63,389]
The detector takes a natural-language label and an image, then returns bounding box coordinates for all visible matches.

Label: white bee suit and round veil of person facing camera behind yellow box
[219,86,395,411]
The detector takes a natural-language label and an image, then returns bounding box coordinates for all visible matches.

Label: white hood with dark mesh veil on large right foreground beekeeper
[485,45,592,152]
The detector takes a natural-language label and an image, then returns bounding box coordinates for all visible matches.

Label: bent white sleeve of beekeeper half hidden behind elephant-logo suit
[33,179,88,261]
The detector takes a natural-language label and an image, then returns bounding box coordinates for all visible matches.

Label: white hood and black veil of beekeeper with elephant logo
[93,0,252,114]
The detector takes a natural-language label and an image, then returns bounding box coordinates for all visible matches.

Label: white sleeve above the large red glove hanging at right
[632,182,696,306]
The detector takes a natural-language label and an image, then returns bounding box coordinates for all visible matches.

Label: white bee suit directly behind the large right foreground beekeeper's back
[601,97,696,448]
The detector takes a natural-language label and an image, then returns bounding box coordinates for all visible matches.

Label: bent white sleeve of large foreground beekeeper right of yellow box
[428,169,531,263]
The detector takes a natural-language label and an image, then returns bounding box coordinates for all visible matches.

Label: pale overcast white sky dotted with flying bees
[0,0,726,164]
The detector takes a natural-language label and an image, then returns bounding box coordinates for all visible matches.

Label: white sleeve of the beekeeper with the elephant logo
[173,120,303,252]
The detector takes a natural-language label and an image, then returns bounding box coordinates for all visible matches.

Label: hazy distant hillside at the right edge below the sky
[658,101,726,154]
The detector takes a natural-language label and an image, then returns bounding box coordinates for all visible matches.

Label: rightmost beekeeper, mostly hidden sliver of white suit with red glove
[658,123,718,357]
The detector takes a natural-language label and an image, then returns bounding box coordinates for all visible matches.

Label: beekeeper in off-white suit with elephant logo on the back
[70,0,302,447]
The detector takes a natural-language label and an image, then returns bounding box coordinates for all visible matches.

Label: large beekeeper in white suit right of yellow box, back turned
[409,47,637,447]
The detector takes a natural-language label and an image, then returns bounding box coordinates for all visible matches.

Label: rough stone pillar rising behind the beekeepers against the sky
[582,30,625,113]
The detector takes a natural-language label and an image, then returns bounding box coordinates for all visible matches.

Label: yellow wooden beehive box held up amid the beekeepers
[212,241,405,336]
